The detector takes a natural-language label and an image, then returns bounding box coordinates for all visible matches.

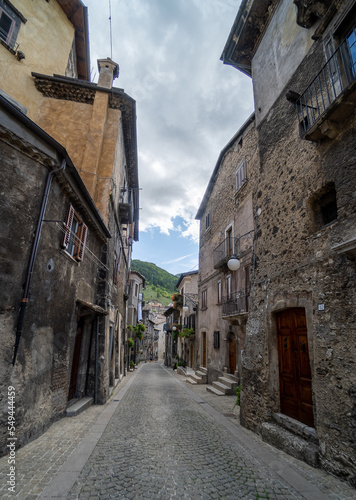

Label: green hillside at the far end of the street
[131,259,180,306]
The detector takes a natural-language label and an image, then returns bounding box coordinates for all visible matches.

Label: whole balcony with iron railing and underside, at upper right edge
[294,35,356,141]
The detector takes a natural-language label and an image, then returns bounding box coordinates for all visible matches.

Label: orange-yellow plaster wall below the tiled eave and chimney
[38,92,124,225]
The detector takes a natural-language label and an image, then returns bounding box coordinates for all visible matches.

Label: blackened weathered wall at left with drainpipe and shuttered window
[0,121,103,454]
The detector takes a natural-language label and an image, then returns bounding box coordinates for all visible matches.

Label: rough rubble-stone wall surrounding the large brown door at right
[241,19,356,484]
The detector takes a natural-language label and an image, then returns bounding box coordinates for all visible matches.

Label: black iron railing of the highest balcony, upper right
[296,37,356,134]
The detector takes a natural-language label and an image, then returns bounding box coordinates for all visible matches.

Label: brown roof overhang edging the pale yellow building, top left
[57,0,90,80]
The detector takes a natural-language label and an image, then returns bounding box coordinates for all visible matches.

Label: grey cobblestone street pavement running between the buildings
[0,364,356,500]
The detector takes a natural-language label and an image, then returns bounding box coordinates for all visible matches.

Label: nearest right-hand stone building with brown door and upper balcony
[222,0,356,486]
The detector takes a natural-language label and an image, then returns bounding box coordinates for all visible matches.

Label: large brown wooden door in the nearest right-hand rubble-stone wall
[277,308,314,427]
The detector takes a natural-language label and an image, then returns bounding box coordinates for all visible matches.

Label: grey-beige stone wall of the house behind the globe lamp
[196,119,258,383]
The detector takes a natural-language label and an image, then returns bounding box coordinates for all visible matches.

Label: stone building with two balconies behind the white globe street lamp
[196,119,258,384]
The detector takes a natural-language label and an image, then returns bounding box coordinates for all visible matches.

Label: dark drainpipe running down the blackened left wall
[12,159,66,366]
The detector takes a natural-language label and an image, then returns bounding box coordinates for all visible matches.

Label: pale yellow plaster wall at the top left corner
[0,0,74,122]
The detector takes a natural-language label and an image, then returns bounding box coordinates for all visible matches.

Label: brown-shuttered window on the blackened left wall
[61,205,88,261]
